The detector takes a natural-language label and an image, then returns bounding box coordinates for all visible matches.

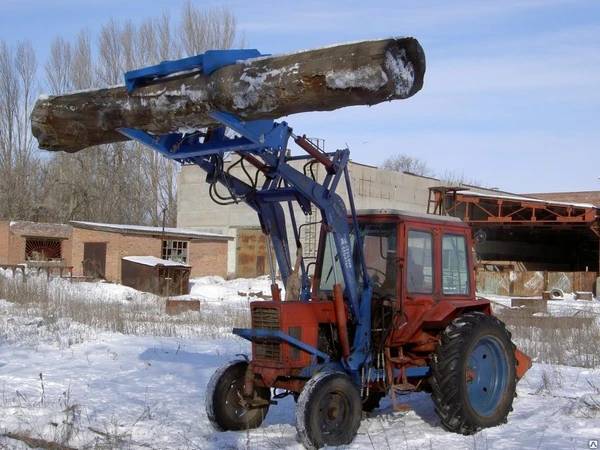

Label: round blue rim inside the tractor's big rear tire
[466,336,509,417]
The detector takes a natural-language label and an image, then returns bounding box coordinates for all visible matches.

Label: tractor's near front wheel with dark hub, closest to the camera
[296,371,362,449]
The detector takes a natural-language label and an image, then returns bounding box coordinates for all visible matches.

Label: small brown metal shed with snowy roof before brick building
[121,256,192,297]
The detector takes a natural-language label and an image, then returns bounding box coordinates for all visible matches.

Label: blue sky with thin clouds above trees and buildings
[0,0,600,194]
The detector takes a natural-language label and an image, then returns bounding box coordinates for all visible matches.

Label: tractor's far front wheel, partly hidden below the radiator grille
[205,360,271,431]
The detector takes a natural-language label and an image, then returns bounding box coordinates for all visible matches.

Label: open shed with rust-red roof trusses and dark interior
[428,186,600,273]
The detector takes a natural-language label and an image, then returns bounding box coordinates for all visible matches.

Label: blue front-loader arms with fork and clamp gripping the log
[119,50,371,370]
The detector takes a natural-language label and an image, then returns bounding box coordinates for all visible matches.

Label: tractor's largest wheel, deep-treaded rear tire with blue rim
[430,312,517,434]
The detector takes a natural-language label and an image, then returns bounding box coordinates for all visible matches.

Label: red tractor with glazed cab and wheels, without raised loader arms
[206,206,530,448]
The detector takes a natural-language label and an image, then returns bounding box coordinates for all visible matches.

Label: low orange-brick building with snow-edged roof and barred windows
[0,221,233,282]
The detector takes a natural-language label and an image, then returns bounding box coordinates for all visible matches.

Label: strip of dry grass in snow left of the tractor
[0,270,250,347]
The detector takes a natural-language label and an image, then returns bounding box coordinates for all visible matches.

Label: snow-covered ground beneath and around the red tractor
[0,274,600,450]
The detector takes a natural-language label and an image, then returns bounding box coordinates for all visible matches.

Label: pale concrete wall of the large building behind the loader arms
[177,161,498,276]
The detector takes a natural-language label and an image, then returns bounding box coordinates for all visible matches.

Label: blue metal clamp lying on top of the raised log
[125,49,268,93]
